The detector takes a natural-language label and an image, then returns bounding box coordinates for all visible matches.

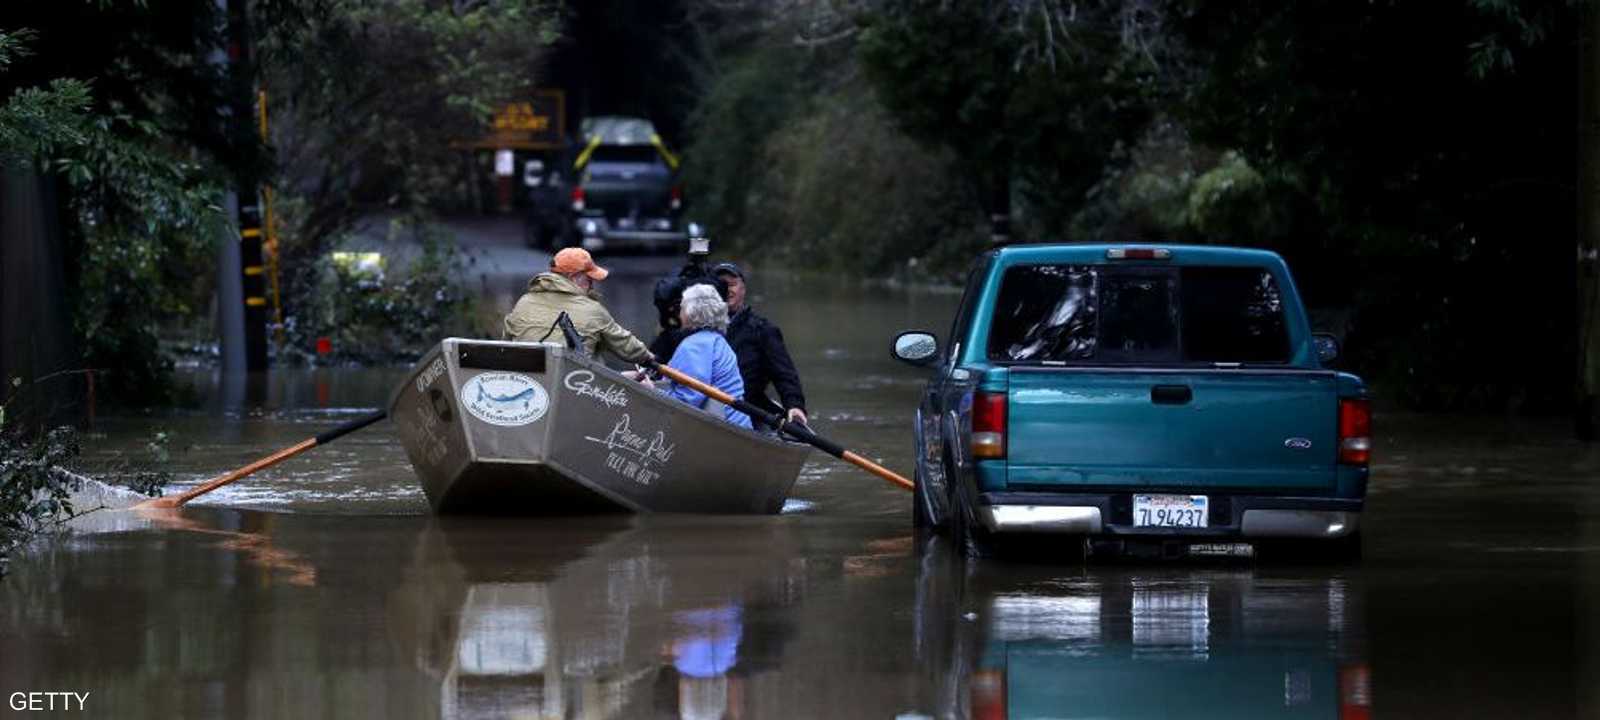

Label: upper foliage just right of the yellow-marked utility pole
[258,0,560,262]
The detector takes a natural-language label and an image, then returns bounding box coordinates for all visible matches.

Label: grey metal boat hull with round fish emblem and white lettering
[389,338,810,515]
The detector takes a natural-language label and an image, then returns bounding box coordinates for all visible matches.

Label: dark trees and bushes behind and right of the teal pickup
[685,0,1600,432]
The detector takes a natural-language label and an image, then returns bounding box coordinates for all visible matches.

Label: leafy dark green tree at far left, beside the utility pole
[0,18,222,408]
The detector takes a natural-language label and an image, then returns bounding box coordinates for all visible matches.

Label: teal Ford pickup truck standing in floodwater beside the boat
[893,245,1371,558]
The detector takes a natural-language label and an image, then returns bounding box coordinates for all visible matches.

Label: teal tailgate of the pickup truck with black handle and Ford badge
[1006,368,1339,494]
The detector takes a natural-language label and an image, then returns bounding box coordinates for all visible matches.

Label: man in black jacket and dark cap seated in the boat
[712,262,806,424]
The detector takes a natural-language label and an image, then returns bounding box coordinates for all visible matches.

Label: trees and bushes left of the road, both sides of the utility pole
[0,0,562,406]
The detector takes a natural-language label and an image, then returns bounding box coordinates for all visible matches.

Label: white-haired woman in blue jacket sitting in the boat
[646,285,750,430]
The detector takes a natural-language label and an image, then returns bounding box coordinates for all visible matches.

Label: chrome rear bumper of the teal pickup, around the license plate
[974,493,1365,539]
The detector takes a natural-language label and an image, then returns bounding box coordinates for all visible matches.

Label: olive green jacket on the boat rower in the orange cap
[506,272,650,363]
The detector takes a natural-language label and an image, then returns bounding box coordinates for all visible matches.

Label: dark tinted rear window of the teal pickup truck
[989,266,1290,365]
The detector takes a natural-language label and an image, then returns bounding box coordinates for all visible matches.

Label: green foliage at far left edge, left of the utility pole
[0,32,226,403]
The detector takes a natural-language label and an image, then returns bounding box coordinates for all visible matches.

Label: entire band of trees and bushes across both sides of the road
[9,0,1600,432]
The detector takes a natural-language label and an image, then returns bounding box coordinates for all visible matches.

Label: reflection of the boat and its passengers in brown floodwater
[389,518,803,718]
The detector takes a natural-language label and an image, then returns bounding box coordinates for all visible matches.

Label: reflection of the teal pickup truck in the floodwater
[923,547,1371,718]
